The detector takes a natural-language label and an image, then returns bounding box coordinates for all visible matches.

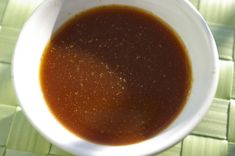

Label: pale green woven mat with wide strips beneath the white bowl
[0,0,235,156]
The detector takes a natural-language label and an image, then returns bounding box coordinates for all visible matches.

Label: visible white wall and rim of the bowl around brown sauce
[13,0,218,156]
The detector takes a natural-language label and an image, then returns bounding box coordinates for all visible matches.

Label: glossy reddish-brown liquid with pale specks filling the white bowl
[40,5,191,145]
